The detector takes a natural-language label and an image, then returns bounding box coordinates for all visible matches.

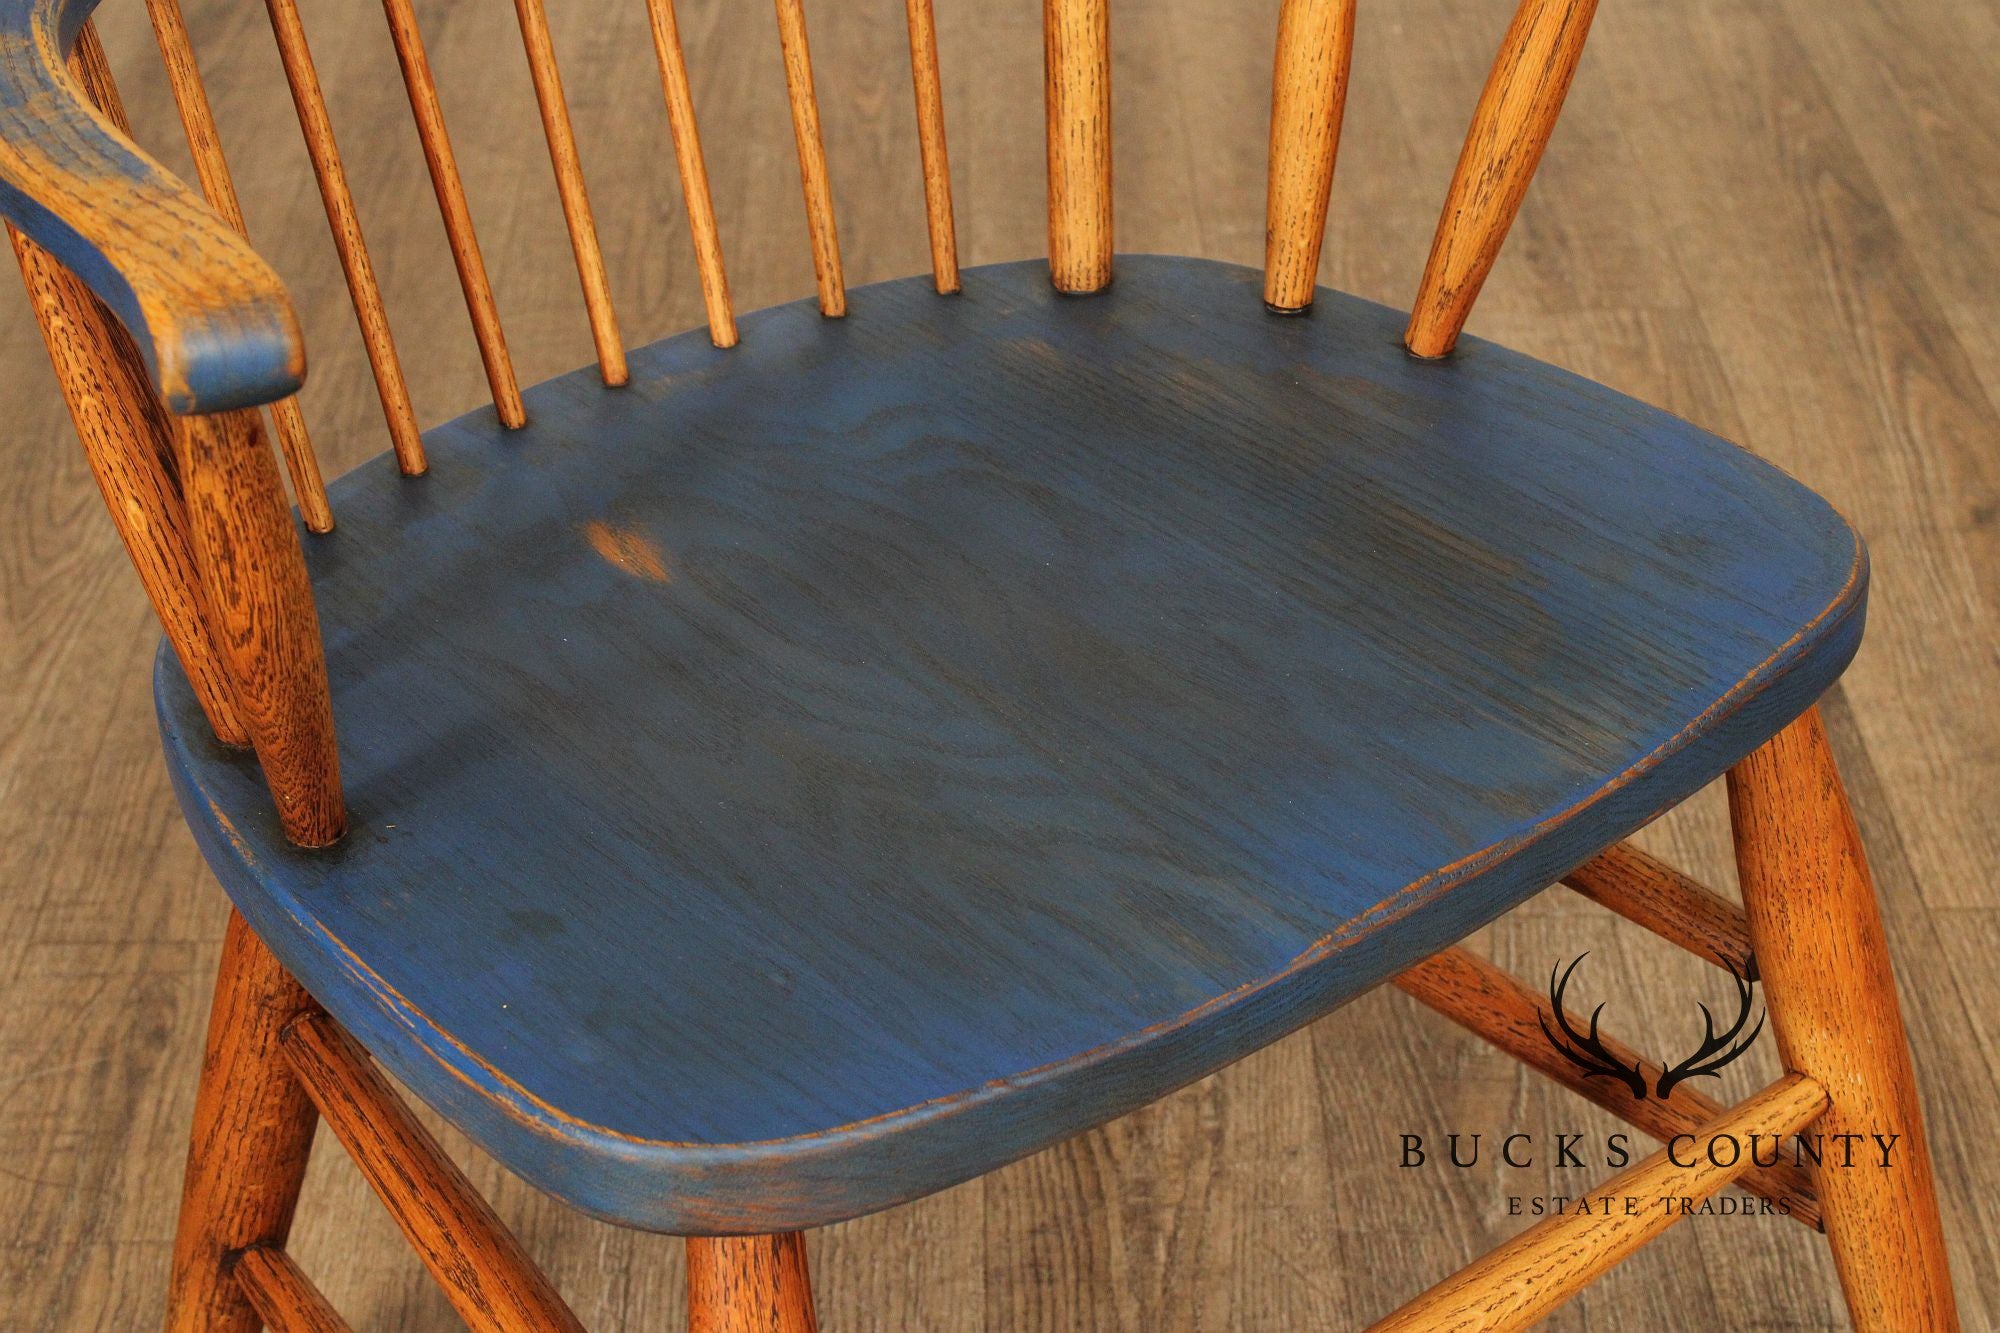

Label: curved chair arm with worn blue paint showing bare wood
[0,0,306,412]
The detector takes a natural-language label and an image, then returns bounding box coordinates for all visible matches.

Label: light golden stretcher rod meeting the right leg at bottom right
[1372,1075,1832,1333]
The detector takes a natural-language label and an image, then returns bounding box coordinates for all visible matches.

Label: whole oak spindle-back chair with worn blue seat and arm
[0,0,1956,1329]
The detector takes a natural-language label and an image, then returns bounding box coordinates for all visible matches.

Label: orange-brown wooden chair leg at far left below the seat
[166,909,318,1333]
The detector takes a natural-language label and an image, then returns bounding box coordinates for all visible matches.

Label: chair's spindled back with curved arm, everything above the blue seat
[0,0,1596,845]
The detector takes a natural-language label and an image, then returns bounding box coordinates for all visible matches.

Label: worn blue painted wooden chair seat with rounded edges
[158,258,1866,1233]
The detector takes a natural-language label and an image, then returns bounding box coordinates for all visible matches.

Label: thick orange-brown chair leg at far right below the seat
[1728,709,1958,1333]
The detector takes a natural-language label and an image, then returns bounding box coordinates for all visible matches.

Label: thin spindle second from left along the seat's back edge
[266,0,428,476]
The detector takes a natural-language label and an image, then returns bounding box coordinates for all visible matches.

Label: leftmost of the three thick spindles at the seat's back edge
[1042,0,1112,296]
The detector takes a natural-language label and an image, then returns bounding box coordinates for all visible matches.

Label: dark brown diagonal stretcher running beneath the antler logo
[1396,947,1820,1231]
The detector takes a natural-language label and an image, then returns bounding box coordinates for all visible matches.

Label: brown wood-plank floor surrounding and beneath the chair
[0,0,2000,1329]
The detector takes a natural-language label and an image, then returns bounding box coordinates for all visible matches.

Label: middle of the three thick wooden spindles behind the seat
[1264,0,1354,314]
